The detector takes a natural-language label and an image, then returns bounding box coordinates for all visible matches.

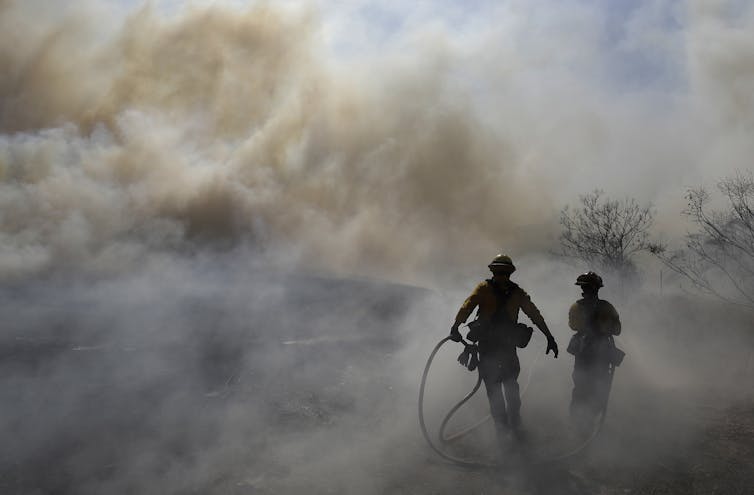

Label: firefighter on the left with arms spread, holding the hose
[450,254,558,439]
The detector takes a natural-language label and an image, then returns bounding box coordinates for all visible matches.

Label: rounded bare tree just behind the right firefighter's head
[560,190,654,278]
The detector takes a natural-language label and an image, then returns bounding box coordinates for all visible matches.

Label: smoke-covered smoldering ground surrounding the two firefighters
[0,253,754,494]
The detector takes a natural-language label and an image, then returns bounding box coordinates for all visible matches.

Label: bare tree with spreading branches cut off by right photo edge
[651,173,754,309]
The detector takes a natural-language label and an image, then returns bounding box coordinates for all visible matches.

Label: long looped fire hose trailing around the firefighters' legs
[419,337,615,468]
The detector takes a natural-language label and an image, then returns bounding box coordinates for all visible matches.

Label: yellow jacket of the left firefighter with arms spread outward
[456,280,547,333]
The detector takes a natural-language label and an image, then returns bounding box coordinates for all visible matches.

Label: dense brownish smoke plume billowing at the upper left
[0,0,546,284]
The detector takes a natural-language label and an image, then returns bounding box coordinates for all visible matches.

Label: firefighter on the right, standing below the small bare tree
[567,272,622,434]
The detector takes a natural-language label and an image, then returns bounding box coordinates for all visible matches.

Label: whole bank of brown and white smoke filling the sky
[0,2,753,286]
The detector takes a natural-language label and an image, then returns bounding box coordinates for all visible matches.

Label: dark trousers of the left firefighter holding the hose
[479,347,521,431]
